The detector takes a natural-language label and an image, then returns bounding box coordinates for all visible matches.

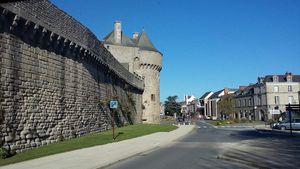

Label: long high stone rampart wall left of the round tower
[0,0,143,152]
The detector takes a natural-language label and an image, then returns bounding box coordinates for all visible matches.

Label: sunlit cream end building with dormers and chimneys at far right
[254,73,300,120]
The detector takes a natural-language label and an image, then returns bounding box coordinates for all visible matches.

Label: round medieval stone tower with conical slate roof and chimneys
[103,21,162,123]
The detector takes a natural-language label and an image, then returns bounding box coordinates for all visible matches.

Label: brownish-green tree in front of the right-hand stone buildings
[218,94,234,120]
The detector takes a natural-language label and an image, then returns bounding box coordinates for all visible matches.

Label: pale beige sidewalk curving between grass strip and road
[0,125,195,169]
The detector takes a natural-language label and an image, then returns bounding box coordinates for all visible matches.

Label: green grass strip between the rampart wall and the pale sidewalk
[0,124,177,166]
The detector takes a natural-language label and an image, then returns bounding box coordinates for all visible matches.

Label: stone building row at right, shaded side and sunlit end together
[234,73,300,121]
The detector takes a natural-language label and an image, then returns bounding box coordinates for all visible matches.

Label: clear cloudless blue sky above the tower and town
[51,0,300,101]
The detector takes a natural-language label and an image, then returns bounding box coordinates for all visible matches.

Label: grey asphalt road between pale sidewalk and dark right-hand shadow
[106,122,255,169]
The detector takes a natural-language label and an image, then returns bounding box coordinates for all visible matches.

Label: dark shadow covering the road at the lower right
[220,129,300,168]
